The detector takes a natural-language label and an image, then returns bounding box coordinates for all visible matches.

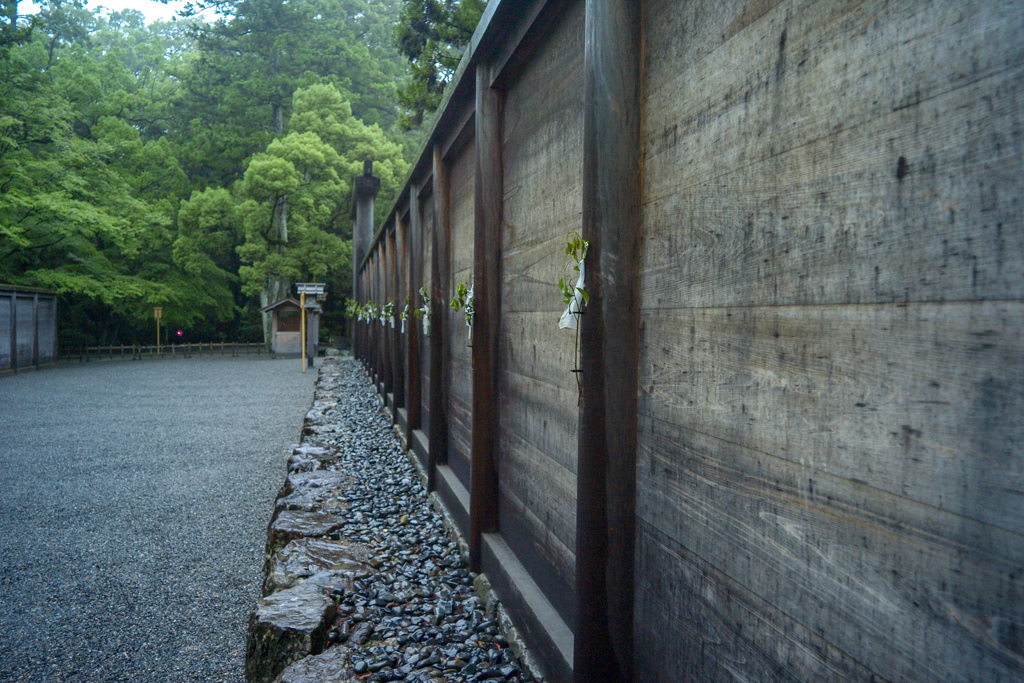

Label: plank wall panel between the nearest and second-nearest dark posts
[498,2,585,622]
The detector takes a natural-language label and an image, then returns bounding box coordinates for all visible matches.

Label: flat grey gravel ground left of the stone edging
[0,358,316,683]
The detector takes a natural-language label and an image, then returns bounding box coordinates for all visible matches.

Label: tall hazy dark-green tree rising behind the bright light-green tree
[173,0,403,186]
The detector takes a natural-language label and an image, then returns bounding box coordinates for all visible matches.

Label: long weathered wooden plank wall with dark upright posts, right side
[357,0,1024,683]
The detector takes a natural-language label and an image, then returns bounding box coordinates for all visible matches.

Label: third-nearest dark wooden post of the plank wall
[427,144,452,490]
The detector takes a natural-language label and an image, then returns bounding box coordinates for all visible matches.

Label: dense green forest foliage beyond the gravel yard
[0,0,483,349]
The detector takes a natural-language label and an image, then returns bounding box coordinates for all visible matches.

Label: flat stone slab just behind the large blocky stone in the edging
[263,539,370,595]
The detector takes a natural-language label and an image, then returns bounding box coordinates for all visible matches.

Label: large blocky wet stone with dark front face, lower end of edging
[246,581,337,683]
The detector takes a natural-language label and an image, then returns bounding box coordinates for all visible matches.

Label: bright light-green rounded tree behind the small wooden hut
[238,84,409,338]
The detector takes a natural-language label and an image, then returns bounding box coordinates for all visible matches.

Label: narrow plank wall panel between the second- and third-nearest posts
[446,141,476,499]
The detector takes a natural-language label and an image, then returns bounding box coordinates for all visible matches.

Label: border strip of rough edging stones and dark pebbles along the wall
[245,358,543,683]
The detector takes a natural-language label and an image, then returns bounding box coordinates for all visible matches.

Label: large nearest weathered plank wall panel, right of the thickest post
[634,0,1024,682]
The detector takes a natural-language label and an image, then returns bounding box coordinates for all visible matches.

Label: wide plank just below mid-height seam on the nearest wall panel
[640,302,1024,533]
